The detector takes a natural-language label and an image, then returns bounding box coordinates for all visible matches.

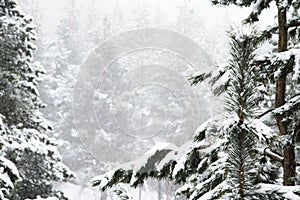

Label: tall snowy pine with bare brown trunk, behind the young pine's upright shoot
[191,0,300,185]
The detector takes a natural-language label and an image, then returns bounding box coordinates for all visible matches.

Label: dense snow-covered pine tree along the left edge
[0,0,73,200]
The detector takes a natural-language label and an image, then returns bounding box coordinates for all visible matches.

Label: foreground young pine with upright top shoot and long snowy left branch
[92,26,300,200]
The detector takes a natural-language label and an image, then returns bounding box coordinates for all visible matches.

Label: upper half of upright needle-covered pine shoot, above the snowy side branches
[226,27,259,120]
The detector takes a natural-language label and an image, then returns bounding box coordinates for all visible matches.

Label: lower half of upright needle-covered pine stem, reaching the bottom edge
[228,123,258,199]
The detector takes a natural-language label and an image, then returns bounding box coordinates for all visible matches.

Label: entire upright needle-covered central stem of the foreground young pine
[226,28,259,199]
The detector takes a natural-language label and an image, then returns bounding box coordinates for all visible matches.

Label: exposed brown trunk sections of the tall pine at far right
[275,8,296,185]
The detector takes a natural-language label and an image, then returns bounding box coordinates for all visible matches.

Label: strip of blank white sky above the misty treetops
[36,0,274,40]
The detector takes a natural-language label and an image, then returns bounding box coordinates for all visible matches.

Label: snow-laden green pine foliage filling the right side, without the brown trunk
[93,0,300,200]
